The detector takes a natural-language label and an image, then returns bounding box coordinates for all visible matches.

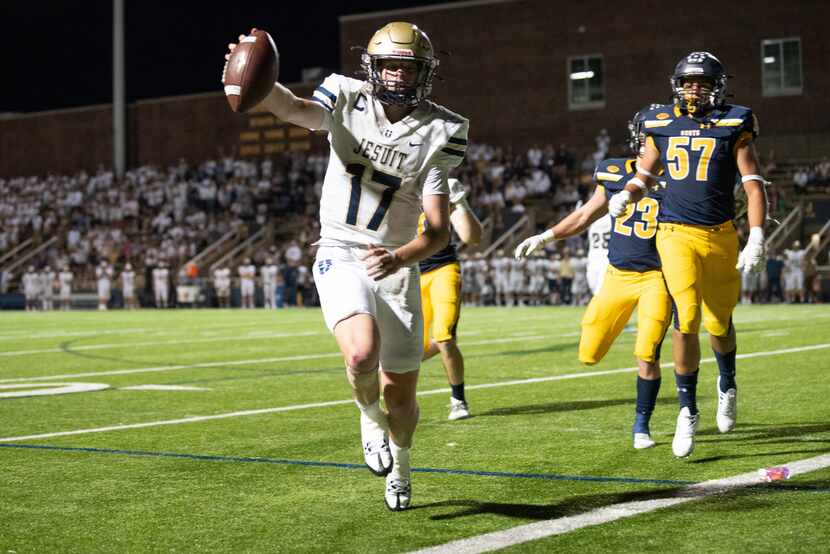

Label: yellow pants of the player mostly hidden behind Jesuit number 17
[421,262,461,352]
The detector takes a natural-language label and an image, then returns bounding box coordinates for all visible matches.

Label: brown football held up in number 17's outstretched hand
[222,29,280,112]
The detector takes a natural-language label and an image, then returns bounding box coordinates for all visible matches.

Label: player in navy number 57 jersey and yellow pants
[609,52,766,457]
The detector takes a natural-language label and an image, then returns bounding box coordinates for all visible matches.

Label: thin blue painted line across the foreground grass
[0,443,830,492]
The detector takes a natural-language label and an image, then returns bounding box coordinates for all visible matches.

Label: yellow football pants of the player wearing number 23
[579,265,671,365]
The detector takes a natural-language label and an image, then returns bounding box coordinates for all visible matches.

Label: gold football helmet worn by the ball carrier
[360,21,438,106]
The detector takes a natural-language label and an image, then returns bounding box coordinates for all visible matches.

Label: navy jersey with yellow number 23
[594,158,663,272]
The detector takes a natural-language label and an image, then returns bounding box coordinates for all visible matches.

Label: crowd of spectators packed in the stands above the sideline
[0,134,830,306]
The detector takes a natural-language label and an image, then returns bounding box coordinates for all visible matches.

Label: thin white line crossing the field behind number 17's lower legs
[0,343,830,442]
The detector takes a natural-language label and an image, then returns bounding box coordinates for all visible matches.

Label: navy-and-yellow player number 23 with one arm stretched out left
[516,105,671,449]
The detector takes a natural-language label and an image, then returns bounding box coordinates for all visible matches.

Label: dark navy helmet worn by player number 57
[669,52,728,115]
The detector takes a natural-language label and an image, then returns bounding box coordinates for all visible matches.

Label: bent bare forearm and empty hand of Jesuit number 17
[364,194,450,281]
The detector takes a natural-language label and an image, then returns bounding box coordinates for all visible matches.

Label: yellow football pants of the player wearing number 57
[657,221,741,337]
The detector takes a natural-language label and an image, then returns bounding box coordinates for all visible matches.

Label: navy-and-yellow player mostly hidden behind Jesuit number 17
[418,179,482,420]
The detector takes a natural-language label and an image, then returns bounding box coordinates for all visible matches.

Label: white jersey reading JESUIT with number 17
[312,73,469,248]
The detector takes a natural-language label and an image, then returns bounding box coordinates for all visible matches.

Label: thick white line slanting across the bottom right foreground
[413,454,830,554]
